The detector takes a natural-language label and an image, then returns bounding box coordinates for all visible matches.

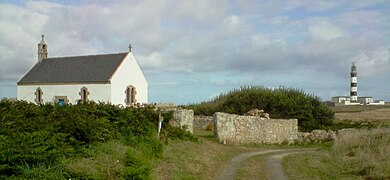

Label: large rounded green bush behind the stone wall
[186,86,334,131]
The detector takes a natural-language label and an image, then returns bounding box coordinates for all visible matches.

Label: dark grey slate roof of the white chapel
[17,52,128,85]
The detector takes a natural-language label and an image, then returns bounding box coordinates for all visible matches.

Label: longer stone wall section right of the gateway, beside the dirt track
[213,112,298,143]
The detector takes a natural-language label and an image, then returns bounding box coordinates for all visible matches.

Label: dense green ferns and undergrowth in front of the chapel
[0,99,196,179]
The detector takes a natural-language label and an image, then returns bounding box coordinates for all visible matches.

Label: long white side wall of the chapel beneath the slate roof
[17,84,111,104]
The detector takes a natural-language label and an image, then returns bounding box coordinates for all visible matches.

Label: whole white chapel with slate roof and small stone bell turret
[17,35,148,106]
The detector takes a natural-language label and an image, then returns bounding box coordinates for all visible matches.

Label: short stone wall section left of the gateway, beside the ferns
[169,108,194,133]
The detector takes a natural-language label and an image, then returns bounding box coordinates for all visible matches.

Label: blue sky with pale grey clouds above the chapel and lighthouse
[0,0,390,104]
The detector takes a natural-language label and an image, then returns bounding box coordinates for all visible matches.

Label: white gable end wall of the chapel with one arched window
[111,52,148,105]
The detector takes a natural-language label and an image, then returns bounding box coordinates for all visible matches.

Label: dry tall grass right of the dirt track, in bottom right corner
[284,128,390,179]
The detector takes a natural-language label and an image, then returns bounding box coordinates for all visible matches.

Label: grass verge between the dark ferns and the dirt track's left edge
[153,131,249,179]
